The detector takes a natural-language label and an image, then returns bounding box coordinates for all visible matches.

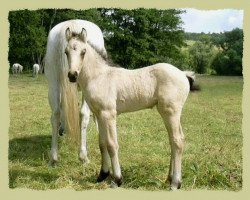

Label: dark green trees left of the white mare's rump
[9,10,46,71]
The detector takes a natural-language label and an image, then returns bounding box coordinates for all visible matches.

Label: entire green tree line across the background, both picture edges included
[8,8,243,75]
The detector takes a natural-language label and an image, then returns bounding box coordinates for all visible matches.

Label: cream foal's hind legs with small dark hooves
[157,104,184,190]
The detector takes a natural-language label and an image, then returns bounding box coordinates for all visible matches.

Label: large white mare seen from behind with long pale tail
[45,20,107,164]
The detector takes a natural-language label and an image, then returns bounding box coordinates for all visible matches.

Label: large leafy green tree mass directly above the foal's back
[97,8,184,68]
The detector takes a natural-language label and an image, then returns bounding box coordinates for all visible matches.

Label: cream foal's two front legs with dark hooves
[97,111,122,186]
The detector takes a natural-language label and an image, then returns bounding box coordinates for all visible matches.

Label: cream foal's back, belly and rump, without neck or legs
[109,63,189,113]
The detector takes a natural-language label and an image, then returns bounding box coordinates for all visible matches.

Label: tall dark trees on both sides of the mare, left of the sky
[9,8,188,70]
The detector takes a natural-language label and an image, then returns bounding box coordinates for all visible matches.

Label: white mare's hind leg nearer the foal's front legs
[79,100,90,163]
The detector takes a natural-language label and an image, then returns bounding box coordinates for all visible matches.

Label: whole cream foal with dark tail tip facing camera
[61,27,198,190]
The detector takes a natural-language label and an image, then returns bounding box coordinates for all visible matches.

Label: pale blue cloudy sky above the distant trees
[181,8,243,33]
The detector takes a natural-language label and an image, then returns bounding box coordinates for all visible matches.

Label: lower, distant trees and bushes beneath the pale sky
[183,28,243,75]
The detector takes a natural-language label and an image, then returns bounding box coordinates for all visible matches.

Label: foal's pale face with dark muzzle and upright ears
[65,28,87,82]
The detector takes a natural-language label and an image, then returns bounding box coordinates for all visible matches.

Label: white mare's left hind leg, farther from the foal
[49,86,60,165]
